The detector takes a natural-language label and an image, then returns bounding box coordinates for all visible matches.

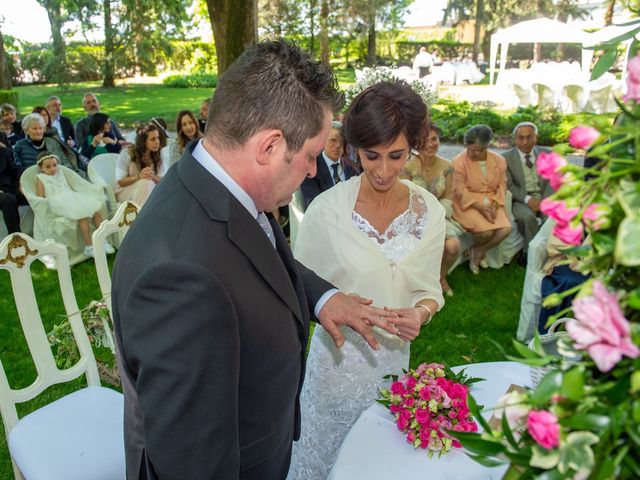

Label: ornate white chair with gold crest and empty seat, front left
[0,233,125,480]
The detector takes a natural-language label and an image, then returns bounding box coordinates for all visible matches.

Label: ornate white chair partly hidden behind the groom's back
[92,202,140,324]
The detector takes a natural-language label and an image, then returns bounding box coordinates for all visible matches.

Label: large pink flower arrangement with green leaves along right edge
[452,51,640,479]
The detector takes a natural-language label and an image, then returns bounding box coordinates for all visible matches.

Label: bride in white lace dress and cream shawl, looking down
[288,81,445,480]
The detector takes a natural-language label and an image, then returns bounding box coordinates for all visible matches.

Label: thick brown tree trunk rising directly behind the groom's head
[207,0,258,77]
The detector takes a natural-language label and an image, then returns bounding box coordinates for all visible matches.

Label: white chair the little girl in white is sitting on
[20,165,107,269]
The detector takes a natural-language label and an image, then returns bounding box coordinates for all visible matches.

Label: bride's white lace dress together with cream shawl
[288,177,445,480]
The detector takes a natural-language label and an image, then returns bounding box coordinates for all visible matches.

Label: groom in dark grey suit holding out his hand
[113,41,397,480]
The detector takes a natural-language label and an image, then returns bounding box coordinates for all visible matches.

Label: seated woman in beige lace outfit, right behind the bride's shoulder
[404,123,463,296]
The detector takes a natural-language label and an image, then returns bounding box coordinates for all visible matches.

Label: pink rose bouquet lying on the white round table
[378,363,479,457]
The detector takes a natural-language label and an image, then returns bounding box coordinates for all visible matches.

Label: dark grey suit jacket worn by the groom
[113,143,332,480]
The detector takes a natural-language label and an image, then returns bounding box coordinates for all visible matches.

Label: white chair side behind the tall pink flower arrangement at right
[516,220,554,342]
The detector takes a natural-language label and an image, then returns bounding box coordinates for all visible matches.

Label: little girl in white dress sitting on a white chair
[36,152,115,257]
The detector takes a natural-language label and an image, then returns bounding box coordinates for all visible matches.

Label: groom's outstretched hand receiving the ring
[318,292,398,350]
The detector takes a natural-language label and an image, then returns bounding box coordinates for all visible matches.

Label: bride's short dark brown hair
[343,80,428,150]
